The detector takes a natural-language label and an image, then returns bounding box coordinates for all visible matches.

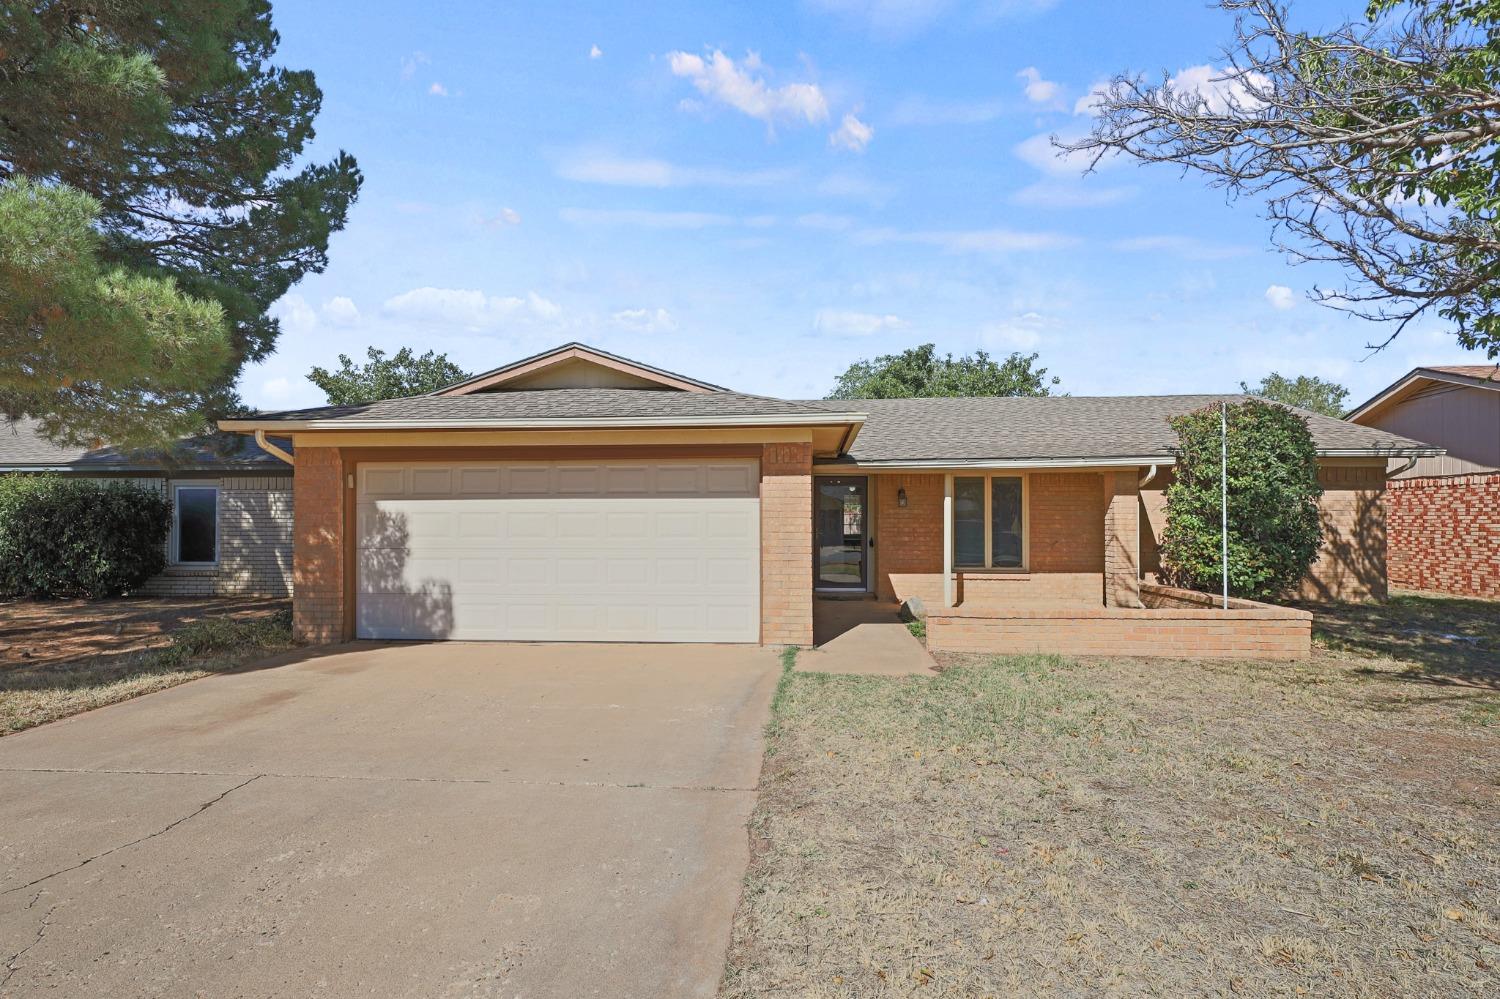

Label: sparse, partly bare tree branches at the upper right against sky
[1062,0,1500,357]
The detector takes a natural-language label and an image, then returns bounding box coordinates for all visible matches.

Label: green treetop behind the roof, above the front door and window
[828,344,1059,399]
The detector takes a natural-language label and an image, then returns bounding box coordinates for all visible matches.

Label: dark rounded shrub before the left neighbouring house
[0,476,173,600]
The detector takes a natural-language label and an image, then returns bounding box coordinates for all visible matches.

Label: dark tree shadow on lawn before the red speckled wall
[1308,593,1500,690]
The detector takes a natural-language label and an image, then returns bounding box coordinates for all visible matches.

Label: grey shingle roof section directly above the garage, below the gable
[238,389,840,423]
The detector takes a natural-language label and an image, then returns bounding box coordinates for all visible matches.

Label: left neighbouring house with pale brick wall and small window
[0,420,293,597]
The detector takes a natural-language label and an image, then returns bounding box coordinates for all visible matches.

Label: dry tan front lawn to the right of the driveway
[722,603,1500,998]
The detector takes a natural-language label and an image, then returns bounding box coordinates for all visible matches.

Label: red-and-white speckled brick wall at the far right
[1386,473,1500,599]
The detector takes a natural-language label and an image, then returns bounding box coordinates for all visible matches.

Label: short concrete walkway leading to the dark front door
[797,600,933,677]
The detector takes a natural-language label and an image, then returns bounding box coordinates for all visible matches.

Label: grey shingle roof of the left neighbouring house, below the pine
[0,420,291,473]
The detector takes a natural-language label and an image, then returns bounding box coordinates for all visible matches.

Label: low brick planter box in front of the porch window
[927,584,1313,660]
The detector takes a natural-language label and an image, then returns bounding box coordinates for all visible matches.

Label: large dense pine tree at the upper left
[0,0,360,444]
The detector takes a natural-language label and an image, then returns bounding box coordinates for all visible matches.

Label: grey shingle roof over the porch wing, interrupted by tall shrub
[824,396,1431,462]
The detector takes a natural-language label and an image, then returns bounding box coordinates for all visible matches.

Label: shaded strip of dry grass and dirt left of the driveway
[0,611,293,735]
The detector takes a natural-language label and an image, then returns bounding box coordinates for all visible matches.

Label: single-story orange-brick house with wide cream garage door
[196,344,1440,659]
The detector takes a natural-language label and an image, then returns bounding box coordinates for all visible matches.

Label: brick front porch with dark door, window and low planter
[813,467,1311,660]
